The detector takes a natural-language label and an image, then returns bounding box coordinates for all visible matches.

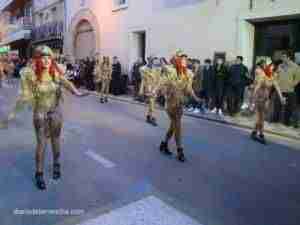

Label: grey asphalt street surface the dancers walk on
[0,81,300,225]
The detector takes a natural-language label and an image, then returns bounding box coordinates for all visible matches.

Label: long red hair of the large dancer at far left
[33,56,63,81]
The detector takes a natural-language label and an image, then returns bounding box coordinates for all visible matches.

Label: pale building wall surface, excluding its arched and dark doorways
[66,0,300,72]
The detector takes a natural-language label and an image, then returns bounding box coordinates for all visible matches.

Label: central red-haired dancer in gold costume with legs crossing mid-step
[160,52,201,162]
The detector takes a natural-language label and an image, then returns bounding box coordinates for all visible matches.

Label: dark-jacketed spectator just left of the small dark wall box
[201,59,215,109]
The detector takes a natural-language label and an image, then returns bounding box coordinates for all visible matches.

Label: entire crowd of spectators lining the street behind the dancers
[0,50,300,127]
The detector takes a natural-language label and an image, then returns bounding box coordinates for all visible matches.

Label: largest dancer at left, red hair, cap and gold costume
[0,46,87,190]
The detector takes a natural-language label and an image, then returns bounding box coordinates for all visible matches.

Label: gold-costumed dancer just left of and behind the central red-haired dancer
[140,57,162,126]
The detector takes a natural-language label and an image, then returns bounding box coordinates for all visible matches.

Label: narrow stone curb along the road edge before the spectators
[90,92,300,141]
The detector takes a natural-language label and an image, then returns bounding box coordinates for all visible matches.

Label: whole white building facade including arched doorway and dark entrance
[65,0,300,73]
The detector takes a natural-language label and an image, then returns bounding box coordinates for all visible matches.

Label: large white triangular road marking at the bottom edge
[77,196,201,225]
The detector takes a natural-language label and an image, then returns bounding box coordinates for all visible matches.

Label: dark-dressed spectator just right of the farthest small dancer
[111,56,122,95]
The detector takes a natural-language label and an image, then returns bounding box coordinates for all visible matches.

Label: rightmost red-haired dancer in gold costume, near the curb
[251,60,285,144]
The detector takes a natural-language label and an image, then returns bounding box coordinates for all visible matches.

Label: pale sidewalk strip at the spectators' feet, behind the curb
[91,91,300,140]
